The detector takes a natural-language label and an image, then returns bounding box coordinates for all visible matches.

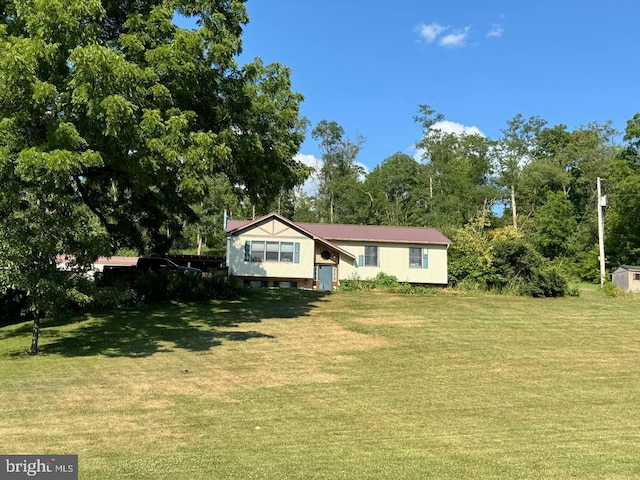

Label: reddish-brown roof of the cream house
[227,213,451,247]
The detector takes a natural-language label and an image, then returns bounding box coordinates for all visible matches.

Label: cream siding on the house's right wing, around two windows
[334,241,448,285]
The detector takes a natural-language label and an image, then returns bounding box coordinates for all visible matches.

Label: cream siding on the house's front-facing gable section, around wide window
[227,219,315,278]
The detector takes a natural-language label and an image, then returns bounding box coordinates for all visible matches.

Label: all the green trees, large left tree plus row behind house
[0,0,640,353]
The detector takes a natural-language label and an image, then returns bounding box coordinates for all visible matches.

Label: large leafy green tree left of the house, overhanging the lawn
[0,0,307,349]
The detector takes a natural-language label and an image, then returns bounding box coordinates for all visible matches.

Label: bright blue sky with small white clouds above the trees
[178,0,640,176]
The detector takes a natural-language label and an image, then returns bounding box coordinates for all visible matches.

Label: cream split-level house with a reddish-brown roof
[226,213,451,290]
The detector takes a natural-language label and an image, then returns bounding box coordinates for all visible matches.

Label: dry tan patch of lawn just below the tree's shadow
[51,317,391,411]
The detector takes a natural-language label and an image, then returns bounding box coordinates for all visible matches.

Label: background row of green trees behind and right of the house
[188,105,640,285]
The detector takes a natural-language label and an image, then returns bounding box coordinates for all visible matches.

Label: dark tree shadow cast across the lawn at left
[33,290,332,357]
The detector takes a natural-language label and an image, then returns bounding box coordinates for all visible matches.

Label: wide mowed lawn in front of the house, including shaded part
[0,289,640,480]
